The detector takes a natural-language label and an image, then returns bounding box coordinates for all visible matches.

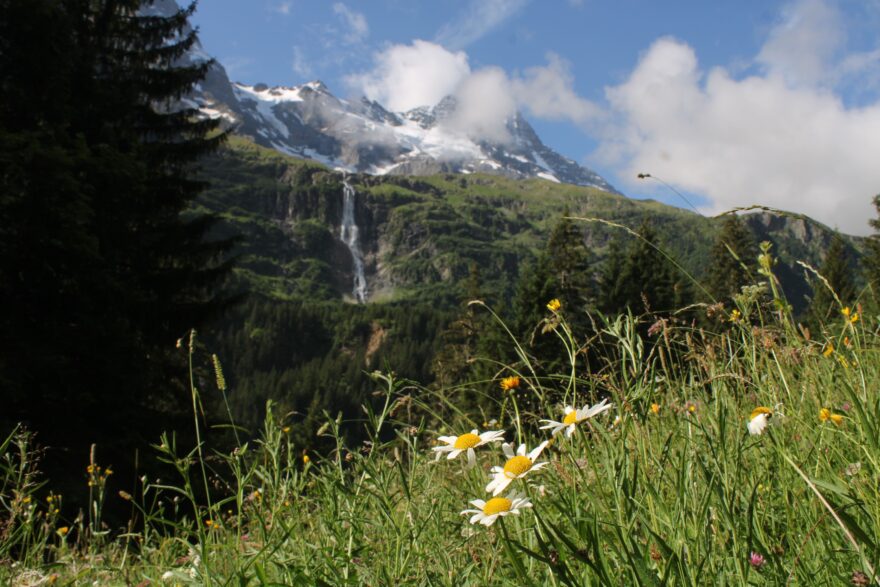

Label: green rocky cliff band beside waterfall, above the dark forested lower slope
[203,138,855,307]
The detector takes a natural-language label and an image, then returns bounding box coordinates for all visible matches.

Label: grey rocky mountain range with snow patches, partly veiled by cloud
[153,0,616,192]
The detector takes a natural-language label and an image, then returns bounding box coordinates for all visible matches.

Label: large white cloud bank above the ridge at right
[599,31,880,234]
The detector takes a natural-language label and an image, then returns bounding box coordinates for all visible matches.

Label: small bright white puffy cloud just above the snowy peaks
[347,40,471,112]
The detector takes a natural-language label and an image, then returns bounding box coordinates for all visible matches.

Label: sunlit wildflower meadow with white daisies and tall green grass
[0,251,880,586]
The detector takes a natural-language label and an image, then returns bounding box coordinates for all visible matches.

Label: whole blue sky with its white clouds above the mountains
[194,0,880,234]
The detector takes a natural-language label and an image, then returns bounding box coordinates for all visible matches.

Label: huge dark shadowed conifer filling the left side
[0,0,230,482]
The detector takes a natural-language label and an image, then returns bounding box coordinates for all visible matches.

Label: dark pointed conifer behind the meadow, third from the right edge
[706,215,758,302]
